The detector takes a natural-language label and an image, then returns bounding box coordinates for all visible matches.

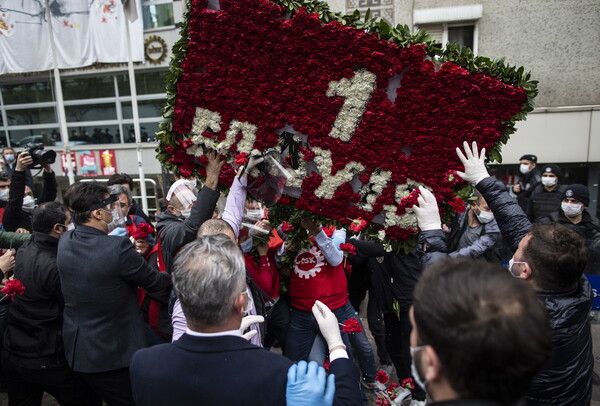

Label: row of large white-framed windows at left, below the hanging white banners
[0,70,166,147]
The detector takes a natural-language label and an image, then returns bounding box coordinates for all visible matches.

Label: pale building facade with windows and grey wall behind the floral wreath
[0,0,600,216]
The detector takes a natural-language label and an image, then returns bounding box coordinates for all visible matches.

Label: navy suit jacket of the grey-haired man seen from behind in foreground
[129,334,361,406]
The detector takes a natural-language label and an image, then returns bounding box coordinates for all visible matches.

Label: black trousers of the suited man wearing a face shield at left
[79,368,135,406]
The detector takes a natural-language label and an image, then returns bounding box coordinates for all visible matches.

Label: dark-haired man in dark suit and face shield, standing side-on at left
[57,183,171,405]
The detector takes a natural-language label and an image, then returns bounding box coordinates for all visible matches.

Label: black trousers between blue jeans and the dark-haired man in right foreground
[383,307,425,400]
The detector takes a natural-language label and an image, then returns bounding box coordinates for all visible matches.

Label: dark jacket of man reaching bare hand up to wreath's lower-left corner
[156,186,220,273]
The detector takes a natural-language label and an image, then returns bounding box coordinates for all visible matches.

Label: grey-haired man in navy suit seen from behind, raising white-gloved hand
[130,234,361,406]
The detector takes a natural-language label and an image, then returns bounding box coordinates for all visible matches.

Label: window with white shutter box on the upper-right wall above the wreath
[413,4,483,53]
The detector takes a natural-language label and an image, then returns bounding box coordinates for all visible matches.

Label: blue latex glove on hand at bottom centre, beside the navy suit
[285,361,335,406]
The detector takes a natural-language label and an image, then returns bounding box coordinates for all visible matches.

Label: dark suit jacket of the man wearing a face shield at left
[57,226,171,373]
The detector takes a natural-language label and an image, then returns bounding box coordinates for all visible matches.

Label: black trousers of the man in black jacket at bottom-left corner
[2,351,94,406]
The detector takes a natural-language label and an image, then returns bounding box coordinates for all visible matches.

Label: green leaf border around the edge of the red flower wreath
[156,0,538,263]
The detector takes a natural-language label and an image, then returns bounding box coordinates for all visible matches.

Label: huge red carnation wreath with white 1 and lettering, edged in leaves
[157,0,537,260]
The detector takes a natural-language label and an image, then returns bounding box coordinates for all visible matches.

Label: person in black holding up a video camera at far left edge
[2,151,57,233]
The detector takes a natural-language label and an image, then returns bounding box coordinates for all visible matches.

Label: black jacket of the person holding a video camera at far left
[2,171,57,231]
